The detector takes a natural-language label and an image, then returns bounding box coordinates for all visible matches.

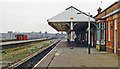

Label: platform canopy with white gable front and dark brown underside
[47,6,95,31]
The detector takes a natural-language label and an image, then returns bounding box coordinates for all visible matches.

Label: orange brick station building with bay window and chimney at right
[94,1,120,54]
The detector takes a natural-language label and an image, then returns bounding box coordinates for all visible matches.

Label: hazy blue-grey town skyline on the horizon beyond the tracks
[0,32,67,39]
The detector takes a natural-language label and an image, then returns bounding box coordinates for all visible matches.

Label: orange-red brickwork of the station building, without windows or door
[95,2,120,54]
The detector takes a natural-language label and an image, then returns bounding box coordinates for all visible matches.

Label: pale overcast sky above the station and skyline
[0,0,117,33]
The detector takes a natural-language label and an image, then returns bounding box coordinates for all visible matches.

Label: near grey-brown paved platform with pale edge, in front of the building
[33,40,118,69]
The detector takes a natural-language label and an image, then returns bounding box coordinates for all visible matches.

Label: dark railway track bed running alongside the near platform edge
[5,40,60,69]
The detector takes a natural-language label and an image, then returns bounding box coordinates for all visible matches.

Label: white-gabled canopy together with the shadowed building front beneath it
[47,6,95,46]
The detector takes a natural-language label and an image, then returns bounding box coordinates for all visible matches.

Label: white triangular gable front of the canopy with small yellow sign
[48,6,95,22]
